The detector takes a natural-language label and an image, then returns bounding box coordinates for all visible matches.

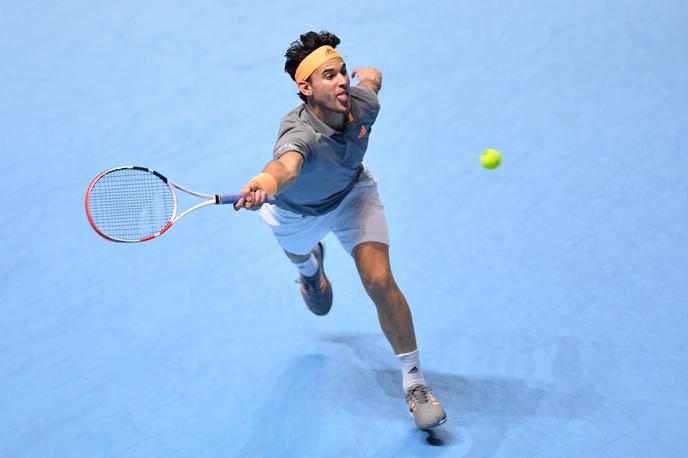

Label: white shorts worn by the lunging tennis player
[260,169,389,255]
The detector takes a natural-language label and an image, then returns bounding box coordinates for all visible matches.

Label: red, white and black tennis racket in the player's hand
[86,166,249,242]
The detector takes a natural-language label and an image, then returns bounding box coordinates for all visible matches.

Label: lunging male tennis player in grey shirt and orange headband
[235,31,446,429]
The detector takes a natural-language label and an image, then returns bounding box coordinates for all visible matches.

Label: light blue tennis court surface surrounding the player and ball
[0,0,688,458]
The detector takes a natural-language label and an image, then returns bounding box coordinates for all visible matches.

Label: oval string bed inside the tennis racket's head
[88,168,176,241]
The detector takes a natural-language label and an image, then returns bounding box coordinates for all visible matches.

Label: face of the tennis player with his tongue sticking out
[311,57,351,113]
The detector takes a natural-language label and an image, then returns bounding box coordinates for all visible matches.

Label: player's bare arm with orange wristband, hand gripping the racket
[234,151,303,210]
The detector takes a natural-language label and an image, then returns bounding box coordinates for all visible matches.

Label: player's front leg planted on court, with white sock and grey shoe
[352,242,447,429]
